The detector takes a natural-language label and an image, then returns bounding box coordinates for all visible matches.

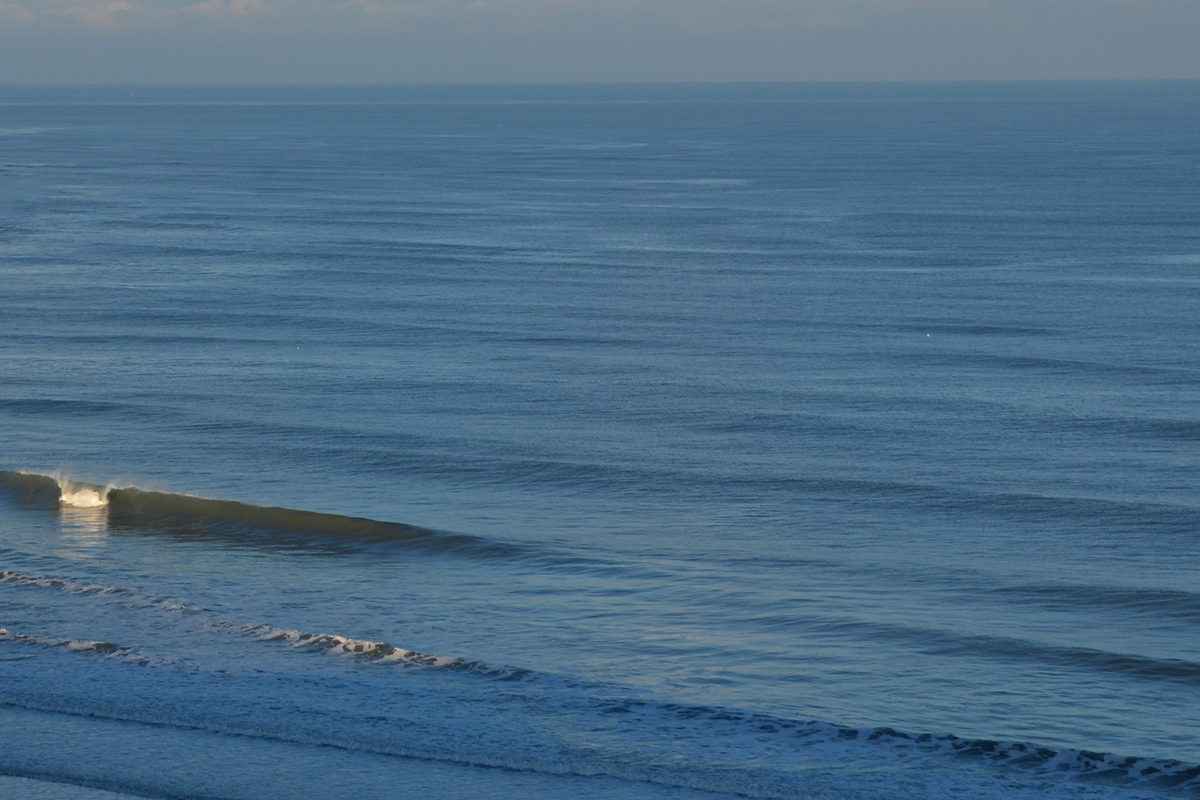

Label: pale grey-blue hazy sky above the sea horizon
[0,0,1200,84]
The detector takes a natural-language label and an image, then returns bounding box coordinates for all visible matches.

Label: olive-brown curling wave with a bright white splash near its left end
[0,471,521,555]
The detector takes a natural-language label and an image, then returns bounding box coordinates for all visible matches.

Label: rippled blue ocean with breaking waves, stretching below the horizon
[0,82,1200,800]
